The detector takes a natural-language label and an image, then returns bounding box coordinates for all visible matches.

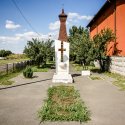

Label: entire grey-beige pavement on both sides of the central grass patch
[0,72,125,125]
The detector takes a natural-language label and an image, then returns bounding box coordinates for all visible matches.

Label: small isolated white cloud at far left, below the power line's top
[5,20,21,29]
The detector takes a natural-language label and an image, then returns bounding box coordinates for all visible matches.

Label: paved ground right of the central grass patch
[75,76,125,125]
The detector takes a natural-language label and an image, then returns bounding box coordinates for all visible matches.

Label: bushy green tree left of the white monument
[24,39,54,67]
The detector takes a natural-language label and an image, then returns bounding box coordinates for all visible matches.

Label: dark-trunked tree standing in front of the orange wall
[92,28,116,71]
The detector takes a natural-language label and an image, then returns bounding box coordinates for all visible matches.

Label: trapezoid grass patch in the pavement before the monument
[38,85,90,122]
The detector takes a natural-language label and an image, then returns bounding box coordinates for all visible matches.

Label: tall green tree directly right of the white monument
[68,26,92,66]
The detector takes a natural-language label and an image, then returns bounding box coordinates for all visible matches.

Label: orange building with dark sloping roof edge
[87,0,125,56]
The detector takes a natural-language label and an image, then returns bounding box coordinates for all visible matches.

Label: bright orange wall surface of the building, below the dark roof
[90,0,125,56]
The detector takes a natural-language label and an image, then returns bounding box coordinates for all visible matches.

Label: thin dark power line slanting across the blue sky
[11,0,41,36]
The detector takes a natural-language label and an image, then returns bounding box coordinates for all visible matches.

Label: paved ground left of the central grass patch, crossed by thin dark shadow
[0,72,53,125]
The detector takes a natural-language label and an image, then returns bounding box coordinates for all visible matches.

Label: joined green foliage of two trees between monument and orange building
[68,26,116,71]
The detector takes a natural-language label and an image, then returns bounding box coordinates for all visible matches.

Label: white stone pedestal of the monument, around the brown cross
[52,40,73,83]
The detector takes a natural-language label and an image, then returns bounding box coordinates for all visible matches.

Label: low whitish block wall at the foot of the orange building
[110,56,125,76]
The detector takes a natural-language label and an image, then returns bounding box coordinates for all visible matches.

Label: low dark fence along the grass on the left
[0,60,34,74]
